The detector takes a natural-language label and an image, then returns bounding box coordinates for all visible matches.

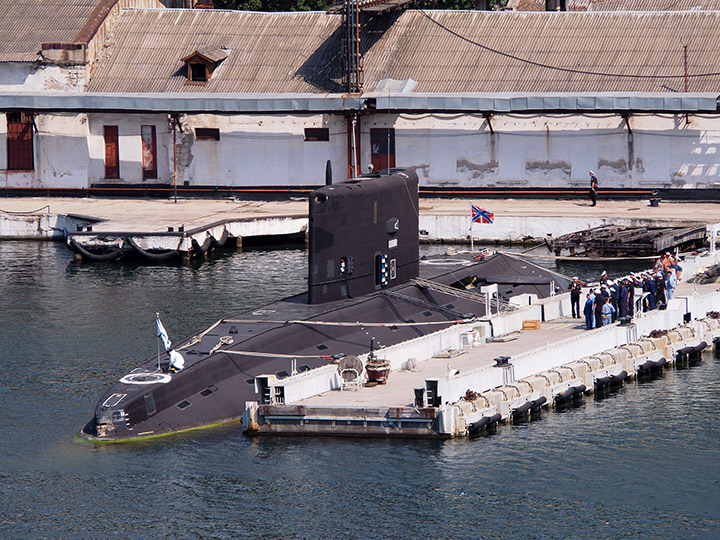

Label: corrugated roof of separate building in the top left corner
[0,0,118,62]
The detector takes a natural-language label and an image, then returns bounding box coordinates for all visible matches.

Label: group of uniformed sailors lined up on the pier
[569,253,682,330]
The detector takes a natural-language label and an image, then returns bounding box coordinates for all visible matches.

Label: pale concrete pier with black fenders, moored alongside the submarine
[244,249,720,437]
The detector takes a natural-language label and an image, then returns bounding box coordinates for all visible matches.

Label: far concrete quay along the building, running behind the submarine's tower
[0,197,717,247]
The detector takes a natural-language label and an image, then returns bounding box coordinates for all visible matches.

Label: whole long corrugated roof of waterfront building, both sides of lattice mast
[88,9,720,93]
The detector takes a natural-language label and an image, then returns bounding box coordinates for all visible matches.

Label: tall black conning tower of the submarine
[308,169,420,304]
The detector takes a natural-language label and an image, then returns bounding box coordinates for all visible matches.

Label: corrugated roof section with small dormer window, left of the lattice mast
[88,9,342,93]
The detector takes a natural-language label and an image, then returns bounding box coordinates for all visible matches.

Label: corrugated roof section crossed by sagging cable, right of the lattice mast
[364,11,720,92]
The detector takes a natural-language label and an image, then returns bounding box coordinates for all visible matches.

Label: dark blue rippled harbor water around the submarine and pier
[0,242,720,539]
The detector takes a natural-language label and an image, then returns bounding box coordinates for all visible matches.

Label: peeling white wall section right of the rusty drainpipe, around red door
[362,114,720,189]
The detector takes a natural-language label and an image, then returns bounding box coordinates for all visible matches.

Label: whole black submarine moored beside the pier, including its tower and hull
[79,169,568,442]
